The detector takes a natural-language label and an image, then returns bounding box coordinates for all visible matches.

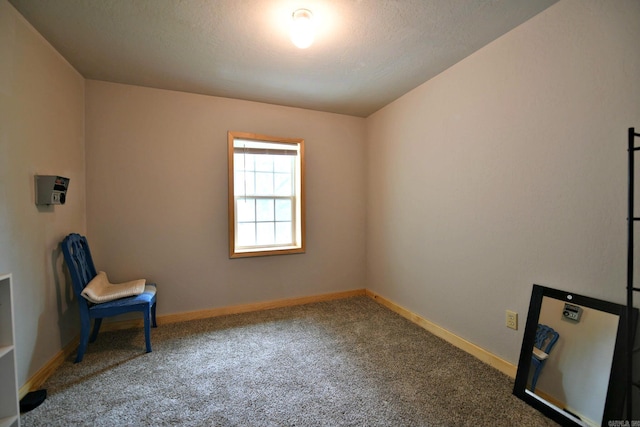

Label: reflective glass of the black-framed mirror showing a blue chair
[527,296,620,426]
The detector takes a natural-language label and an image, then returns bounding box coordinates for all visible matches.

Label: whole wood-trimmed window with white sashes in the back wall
[228,132,305,258]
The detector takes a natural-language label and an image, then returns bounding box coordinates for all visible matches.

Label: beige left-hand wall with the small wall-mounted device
[0,0,86,385]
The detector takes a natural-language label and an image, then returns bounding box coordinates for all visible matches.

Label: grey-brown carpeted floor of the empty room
[21,297,555,426]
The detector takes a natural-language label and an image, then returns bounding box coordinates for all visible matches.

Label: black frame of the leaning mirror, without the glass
[513,284,638,426]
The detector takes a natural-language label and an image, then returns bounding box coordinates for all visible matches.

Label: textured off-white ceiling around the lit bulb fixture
[9,0,557,117]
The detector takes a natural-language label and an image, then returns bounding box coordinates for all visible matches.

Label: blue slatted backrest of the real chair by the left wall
[62,233,98,301]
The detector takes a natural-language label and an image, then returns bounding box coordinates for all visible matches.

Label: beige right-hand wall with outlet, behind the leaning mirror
[366,0,640,364]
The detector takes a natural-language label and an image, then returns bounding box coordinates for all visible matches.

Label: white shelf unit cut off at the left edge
[0,274,20,427]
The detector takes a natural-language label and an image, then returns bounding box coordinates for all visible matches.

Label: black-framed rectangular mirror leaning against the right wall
[513,285,638,426]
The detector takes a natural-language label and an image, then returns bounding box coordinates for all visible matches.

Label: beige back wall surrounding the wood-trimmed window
[86,81,365,314]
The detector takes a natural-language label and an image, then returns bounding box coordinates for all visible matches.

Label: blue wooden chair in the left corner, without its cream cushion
[62,233,157,363]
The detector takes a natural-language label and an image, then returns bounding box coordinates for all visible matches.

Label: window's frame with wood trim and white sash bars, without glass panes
[228,131,305,258]
